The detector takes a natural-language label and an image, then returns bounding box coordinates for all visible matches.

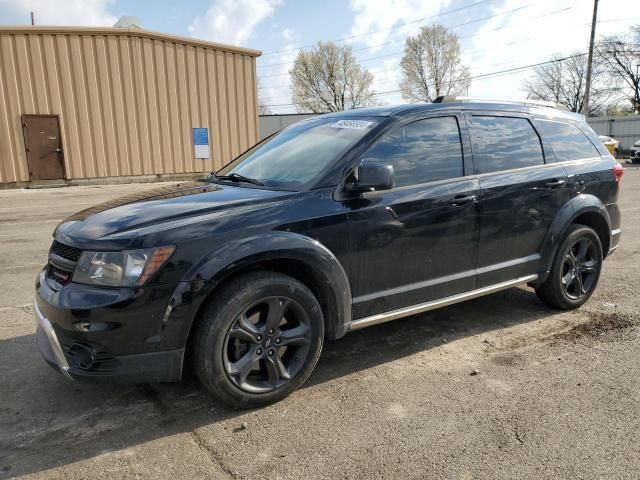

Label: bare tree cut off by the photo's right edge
[597,25,640,113]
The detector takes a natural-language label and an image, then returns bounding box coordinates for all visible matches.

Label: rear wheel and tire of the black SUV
[536,224,603,310]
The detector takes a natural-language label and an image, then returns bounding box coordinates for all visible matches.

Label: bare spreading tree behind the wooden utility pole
[523,52,617,114]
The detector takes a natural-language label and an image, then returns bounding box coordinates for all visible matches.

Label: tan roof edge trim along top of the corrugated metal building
[0,25,262,57]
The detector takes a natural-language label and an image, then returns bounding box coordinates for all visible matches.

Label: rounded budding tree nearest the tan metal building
[289,42,375,113]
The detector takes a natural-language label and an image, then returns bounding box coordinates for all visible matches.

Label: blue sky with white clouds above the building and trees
[0,0,640,113]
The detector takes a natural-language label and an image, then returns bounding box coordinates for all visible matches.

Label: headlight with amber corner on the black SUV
[73,245,175,287]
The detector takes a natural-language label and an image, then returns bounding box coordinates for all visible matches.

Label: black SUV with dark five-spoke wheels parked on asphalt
[34,102,623,407]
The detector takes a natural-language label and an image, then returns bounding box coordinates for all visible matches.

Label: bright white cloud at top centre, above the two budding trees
[348,0,452,52]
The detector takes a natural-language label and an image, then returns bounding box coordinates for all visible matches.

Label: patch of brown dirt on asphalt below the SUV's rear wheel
[555,312,640,341]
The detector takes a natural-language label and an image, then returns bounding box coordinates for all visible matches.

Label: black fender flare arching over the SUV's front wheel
[164,232,351,352]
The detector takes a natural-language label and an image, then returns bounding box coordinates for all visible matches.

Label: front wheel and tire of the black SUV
[193,271,324,408]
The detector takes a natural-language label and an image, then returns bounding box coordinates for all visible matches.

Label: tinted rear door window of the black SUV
[471,115,544,173]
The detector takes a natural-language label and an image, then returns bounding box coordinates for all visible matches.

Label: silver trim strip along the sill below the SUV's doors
[349,273,538,331]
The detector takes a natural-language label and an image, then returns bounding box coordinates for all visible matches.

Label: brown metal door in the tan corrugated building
[22,115,64,180]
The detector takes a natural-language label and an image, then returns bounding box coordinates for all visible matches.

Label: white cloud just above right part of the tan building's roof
[188,0,282,45]
